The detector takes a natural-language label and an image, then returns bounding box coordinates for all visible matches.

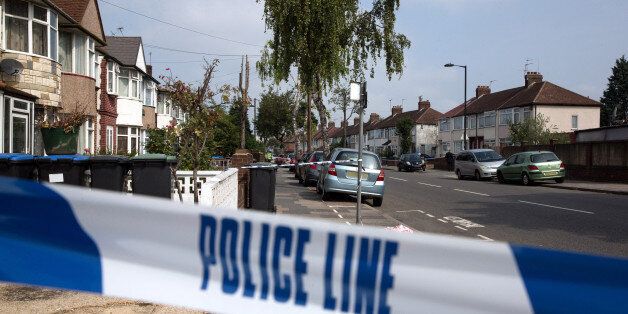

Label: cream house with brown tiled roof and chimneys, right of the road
[437,72,601,156]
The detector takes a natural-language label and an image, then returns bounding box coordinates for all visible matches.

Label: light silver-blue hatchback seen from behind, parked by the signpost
[316,148,384,206]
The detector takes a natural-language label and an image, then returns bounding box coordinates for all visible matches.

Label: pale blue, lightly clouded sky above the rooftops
[99,0,628,125]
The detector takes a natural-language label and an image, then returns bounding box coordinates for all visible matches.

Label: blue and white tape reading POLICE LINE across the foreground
[0,178,628,313]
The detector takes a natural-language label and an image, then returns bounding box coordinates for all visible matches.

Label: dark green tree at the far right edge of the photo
[600,56,628,126]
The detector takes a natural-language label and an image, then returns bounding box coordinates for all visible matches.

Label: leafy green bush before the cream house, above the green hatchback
[509,113,569,146]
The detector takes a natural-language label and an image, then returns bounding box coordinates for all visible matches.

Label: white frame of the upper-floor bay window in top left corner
[0,1,59,61]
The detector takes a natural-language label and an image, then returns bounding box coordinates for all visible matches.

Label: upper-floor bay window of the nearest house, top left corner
[4,0,58,60]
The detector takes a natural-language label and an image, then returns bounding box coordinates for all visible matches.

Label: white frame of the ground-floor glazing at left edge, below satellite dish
[0,95,35,154]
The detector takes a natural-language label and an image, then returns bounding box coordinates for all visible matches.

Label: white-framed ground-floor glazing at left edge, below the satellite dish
[0,96,34,154]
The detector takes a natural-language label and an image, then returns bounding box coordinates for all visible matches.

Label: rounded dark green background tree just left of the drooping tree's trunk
[255,89,294,143]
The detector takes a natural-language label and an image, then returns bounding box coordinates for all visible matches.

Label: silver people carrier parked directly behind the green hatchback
[454,149,505,180]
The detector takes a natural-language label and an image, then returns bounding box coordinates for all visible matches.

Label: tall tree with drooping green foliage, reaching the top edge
[257,0,410,152]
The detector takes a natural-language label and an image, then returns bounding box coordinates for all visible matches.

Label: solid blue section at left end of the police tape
[0,177,102,293]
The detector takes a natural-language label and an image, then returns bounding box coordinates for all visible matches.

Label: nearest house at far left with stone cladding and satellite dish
[0,0,105,154]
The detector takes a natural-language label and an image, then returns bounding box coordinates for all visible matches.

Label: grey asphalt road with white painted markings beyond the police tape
[277,169,628,257]
